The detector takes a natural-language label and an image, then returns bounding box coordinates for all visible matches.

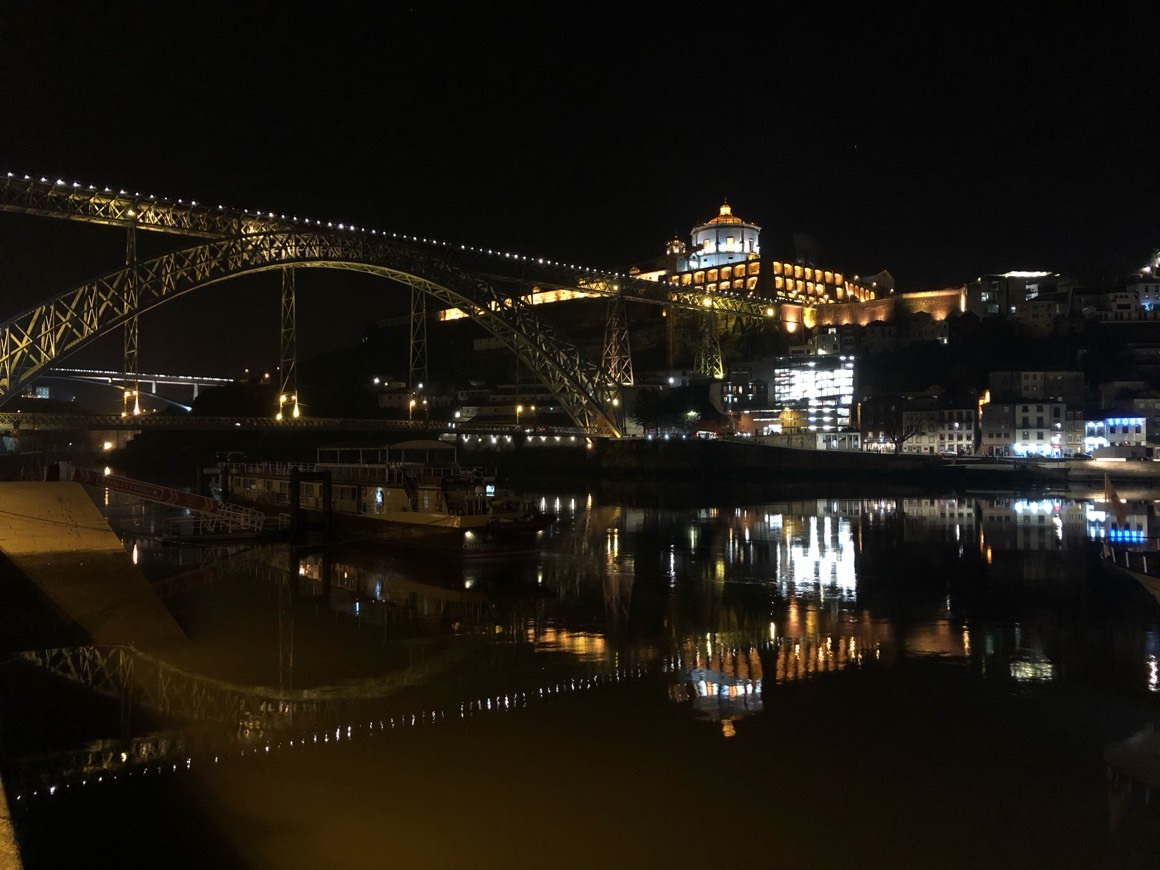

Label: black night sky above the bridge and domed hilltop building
[0,0,1160,375]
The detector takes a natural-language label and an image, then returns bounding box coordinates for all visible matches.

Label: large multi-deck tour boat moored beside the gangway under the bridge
[218,441,556,558]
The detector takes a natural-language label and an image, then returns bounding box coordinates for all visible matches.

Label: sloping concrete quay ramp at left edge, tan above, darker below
[0,481,188,651]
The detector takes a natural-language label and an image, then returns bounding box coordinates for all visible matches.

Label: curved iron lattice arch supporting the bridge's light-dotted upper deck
[0,231,621,437]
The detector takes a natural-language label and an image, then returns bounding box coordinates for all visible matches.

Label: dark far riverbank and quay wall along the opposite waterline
[115,430,1160,498]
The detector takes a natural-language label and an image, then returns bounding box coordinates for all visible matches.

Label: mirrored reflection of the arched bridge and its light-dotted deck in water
[5,646,663,800]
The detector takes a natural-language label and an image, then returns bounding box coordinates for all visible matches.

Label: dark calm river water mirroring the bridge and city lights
[0,493,1160,870]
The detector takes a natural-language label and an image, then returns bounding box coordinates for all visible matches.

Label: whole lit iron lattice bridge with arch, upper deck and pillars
[0,173,793,436]
